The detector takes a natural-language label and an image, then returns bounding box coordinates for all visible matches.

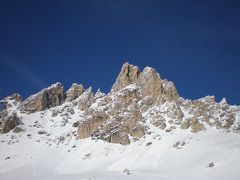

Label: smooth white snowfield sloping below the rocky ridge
[0,111,240,180]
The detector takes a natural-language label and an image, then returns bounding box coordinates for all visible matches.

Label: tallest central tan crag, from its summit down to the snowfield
[75,63,179,144]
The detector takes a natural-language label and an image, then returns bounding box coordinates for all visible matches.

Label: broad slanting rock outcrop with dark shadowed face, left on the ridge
[20,83,65,113]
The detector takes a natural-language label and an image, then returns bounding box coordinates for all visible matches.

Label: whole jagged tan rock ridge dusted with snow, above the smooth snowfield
[0,63,240,145]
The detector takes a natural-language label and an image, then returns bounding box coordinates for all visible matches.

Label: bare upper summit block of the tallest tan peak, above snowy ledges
[111,63,179,102]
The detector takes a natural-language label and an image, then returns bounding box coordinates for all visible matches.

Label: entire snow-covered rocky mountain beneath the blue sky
[0,63,240,180]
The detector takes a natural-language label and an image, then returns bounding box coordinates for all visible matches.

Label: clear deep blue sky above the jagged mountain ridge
[0,0,240,105]
